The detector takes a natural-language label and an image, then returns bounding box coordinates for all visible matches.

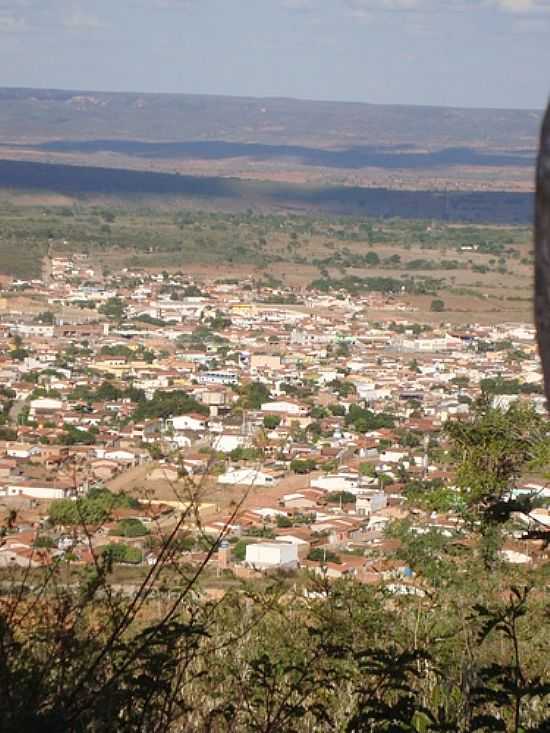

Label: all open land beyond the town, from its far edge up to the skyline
[0,88,541,304]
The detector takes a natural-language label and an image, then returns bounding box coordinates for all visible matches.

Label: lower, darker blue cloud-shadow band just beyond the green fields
[0,160,532,224]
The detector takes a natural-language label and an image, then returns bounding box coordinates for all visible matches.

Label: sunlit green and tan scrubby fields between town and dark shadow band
[0,195,532,323]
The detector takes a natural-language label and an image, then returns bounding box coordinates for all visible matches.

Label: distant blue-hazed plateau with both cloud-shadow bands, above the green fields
[0,88,542,223]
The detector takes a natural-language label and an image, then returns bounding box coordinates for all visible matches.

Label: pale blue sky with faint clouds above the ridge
[0,0,550,109]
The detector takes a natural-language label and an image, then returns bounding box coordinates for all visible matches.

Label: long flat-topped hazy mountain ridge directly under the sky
[0,88,542,149]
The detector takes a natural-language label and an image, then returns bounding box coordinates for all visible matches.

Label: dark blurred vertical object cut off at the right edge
[535,101,550,401]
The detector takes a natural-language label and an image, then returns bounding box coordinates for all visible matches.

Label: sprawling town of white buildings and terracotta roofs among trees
[0,254,550,594]
